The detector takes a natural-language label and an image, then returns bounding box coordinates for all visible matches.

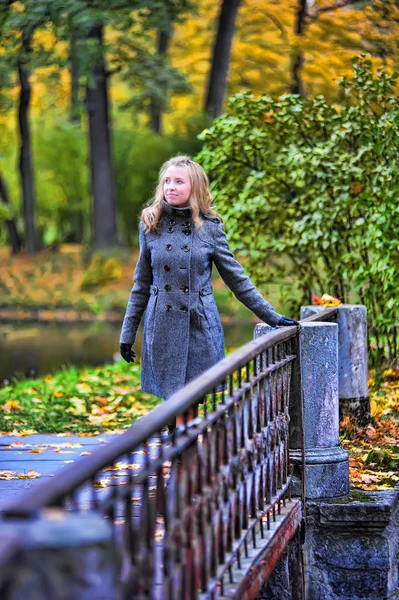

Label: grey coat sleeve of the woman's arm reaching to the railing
[213,223,282,327]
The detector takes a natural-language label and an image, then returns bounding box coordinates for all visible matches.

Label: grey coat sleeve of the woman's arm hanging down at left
[119,223,152,344]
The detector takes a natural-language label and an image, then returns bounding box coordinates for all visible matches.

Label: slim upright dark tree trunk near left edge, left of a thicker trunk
[18,32,37,254]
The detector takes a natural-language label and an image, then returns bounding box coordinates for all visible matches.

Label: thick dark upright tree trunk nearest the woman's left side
[86,25,117,247]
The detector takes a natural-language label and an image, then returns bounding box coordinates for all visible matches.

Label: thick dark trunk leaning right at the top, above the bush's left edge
[205,0,241,118]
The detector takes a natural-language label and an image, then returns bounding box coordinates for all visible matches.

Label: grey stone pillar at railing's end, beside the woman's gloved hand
[255,322,349,499]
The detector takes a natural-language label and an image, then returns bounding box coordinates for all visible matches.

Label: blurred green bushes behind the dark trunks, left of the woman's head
[0,119,205,246]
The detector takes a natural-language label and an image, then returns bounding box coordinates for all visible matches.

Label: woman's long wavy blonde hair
[140,156,222,232]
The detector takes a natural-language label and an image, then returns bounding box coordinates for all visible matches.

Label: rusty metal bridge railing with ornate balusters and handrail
[3,309,337,600]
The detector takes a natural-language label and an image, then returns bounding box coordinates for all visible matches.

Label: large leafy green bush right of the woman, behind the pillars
[199,58,399,359]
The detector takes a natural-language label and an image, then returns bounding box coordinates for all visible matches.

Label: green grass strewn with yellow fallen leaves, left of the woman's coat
[0,361,159,434]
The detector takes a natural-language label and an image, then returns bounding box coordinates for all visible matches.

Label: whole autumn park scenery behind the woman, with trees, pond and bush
[0,0,399,486]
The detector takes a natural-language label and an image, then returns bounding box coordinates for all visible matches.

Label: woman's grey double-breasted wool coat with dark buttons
[120,201,281,398]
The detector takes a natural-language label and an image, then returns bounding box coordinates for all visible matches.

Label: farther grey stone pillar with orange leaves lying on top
[301,304,370,427]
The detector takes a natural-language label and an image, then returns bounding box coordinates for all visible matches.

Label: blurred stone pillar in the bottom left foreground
[0,509,117,600]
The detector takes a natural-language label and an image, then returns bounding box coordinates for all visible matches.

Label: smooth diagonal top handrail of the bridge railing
[3,308,337,518]
